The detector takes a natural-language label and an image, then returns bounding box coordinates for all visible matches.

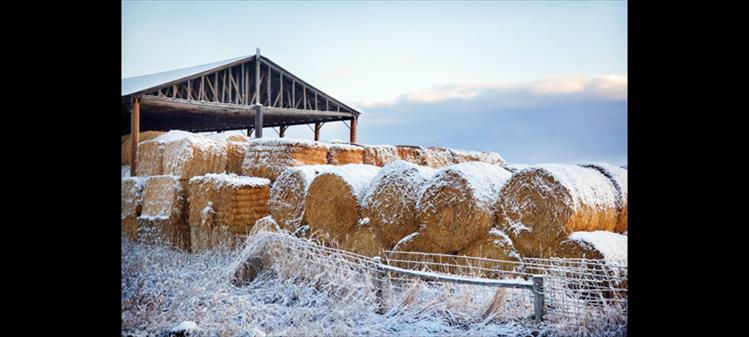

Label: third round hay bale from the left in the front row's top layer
[362,160,435,247]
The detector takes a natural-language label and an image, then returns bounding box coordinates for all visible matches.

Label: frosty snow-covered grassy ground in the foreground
[121,235,626,336]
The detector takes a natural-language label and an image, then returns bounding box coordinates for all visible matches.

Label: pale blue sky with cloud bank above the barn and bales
[122,1,627,165]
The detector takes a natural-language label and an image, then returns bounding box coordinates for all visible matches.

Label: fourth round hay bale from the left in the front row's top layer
[416,162,511,252]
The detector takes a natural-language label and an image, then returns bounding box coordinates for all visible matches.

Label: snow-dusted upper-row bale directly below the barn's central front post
[242,138,328,181]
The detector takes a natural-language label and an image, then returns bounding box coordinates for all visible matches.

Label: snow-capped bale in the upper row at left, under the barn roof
[161,131,227,179]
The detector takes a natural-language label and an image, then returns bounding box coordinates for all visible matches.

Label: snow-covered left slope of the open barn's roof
[120,55,254,96]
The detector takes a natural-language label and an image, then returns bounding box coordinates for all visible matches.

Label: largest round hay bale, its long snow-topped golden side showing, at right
[497,164,617,257]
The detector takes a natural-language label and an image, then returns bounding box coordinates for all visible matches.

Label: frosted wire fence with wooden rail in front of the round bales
[235,232,627,322]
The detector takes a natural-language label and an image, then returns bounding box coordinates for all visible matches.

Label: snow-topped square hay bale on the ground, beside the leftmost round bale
[188,174,270,251]
